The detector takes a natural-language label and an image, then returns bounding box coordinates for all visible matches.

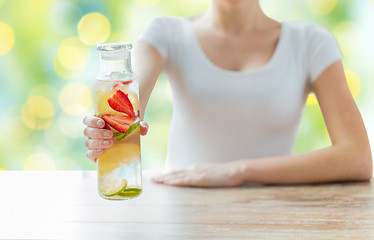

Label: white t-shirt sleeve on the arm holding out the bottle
[137,17,169,61]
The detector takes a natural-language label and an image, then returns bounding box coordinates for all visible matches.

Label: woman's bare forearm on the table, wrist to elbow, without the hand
[235,145,372,184]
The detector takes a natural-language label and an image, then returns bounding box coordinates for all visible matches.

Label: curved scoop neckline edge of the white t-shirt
[183,17,286,75]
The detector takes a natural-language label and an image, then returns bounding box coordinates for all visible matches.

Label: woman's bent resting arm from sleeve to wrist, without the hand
[243,62,373,183]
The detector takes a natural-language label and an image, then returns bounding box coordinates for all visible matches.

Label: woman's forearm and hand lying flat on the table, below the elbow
[153,143,372,187]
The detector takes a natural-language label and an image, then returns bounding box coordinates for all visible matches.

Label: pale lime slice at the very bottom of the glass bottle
[99,174,127,197]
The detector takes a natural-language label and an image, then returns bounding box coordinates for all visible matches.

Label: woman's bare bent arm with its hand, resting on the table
[154,62,373,186]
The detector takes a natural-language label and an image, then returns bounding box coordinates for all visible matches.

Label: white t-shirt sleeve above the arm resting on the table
[307,23,343,84]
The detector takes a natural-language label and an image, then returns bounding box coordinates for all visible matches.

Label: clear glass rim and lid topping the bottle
[96,42,132,60]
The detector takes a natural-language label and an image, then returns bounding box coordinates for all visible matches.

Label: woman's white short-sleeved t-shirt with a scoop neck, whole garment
[138,17,342,169]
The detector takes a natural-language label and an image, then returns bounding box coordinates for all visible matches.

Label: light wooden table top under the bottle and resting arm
[0,171,374,240]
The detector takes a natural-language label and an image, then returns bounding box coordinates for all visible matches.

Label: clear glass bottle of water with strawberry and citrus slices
[94,43,142,200]
